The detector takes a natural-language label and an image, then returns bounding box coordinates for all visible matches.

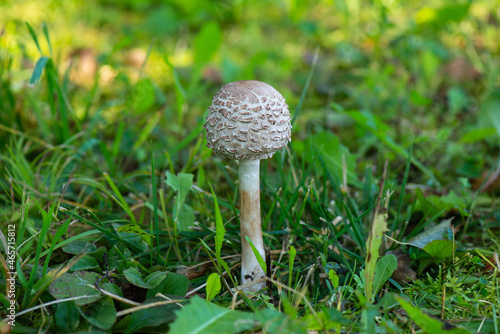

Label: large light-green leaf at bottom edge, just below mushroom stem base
[170,296,256,334]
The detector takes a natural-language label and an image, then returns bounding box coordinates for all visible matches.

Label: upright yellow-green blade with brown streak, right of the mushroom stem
[365,207,387,301]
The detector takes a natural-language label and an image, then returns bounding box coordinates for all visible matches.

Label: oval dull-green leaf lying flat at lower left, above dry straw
[49,271,102,306]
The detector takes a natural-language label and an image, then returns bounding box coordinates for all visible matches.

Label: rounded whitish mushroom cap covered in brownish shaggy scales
[204,80,292,160]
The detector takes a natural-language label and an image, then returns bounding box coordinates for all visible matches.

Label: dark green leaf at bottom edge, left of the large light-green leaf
[125,297,180,334]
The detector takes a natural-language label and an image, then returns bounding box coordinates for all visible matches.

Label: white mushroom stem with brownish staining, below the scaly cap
[240,160,265,292]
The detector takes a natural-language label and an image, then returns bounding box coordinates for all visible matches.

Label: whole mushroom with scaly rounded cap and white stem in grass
[204,80,292,292]
